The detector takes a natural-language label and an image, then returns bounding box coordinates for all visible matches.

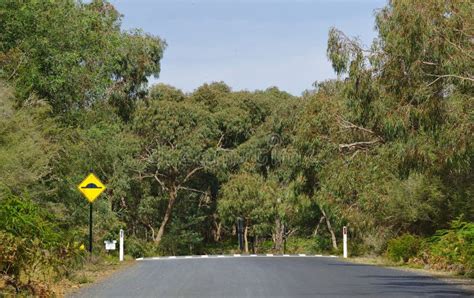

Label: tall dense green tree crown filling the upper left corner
[0,0,166,121]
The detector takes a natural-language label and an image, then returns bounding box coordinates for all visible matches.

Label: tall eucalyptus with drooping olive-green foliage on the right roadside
[324,1,474,244]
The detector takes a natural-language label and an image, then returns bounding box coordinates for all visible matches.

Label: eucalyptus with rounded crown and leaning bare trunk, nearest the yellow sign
[133,99,219,244]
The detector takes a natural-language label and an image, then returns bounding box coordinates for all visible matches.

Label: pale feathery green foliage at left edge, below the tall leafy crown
[0,81,58,193]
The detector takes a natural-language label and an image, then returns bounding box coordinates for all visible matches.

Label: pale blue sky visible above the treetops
[111,0,386,95]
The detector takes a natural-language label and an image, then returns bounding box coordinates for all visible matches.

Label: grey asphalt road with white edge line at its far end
[74,256,474,298]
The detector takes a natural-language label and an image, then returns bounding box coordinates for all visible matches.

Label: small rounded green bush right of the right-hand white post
[387,234,421,263]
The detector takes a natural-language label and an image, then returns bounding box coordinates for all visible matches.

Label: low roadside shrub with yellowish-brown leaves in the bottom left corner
[0,195,80,295]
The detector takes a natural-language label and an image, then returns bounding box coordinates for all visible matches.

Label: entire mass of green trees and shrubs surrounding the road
[0,0,474,290]
